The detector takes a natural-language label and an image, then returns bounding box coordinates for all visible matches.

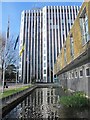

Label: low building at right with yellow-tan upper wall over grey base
[54,2,90,97]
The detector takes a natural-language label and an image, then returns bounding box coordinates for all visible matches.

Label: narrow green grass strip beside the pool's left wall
[0,85,32,99]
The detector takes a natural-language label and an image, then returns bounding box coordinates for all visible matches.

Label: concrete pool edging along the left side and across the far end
[0,83,60,118]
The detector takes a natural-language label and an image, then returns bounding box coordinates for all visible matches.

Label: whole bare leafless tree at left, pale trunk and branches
[0,32,19,91]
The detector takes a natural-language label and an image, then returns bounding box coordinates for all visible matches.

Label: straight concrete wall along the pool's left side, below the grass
[0,85,37,118]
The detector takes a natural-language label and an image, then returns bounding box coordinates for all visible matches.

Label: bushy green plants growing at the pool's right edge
[59,92,90,108]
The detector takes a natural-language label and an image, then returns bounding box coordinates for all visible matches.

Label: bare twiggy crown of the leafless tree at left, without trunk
[0,33,18,77]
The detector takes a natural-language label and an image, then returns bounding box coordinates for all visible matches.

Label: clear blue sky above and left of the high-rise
[0,2,82,39]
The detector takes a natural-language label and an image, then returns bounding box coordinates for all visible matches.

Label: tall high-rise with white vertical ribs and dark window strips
[19,6,80,83]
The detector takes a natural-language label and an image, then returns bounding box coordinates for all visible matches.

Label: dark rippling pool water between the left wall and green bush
[3,87,90,120]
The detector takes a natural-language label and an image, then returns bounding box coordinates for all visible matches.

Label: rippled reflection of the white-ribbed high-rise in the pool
[5,88,58,120]
